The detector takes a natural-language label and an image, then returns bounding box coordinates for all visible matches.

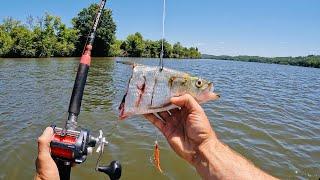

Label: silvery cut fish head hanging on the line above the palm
[118,62,220,120]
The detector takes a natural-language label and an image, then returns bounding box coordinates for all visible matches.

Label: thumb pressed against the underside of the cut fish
[170,94,201,111]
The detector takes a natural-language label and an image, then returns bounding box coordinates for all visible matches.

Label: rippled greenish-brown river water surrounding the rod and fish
[0,58,320,180]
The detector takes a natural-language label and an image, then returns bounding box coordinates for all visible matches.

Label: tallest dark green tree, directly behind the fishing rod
[72,4,116,56]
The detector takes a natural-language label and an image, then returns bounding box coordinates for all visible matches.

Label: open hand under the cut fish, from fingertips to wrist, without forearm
[144,94,217,165]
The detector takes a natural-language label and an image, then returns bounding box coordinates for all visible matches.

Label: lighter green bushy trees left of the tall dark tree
[0,13,77,57]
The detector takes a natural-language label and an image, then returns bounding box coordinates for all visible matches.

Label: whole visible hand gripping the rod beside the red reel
[34,127,60,180]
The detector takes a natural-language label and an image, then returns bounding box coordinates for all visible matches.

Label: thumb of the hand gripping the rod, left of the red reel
[38,127,53,154]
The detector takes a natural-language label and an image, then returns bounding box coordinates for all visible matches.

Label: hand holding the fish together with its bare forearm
[145,94,274,179]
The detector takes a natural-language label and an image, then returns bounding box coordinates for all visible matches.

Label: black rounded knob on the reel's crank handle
[98,161,122,180]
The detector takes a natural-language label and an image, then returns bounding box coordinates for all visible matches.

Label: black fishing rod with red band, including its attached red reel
[50,0,122,180]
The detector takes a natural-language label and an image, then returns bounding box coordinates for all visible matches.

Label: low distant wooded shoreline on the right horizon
[202,54,320,68]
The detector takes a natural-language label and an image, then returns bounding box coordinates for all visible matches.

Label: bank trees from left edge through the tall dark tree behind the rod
[0,4,116,57]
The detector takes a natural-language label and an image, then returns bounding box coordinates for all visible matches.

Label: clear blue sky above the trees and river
[0,0,320,57]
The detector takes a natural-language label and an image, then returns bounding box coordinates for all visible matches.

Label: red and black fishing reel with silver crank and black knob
[50,125,122,180]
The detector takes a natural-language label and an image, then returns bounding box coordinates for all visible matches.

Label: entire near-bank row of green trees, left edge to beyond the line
[0,4,201,58]
